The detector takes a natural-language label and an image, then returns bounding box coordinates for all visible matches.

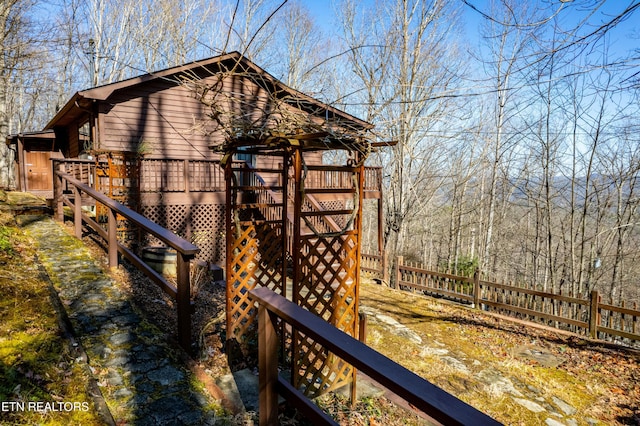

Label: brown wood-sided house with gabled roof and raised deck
[36,52,381,265]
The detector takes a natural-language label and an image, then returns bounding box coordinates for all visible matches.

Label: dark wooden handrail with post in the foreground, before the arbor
[249,287,500,425]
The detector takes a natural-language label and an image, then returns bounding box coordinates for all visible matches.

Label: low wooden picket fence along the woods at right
[362,254,640,345]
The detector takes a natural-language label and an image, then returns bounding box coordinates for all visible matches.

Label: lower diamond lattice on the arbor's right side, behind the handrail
[293,232,358,398]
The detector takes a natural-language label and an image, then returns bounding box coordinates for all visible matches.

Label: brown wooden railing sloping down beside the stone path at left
[53,162,200,351]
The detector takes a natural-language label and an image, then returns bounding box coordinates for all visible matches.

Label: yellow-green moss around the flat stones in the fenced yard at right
[360,285,620,425]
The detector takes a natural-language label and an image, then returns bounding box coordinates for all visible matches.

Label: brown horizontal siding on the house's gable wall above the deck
[98,71,336,162]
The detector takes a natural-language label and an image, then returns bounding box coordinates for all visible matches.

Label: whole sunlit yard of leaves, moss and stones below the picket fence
[360,284,640,425]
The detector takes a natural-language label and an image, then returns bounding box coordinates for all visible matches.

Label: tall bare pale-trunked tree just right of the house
[342,1,464,262]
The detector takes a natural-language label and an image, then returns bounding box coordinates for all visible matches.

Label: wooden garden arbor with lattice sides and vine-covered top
[221,131,370,397]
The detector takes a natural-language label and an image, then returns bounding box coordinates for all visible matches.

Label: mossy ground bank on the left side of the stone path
[0,221,101,425]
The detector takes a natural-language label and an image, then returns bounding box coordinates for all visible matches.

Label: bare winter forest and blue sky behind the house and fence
[0,0,640,303]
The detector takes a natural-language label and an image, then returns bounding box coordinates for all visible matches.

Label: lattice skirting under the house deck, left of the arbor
[141,204,225,264]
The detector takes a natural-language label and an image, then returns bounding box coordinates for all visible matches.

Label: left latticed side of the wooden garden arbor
[225,156,287,353]
